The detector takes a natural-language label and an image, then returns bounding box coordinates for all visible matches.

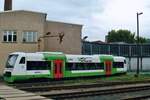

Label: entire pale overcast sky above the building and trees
[0,0,150,41]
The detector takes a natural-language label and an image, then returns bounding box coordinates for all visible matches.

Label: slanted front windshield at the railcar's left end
[6,55,18,68]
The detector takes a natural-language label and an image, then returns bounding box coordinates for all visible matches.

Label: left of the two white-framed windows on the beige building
[3,31,17,42]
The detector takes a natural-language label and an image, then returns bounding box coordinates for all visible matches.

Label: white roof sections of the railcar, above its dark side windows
[10,52,125,62]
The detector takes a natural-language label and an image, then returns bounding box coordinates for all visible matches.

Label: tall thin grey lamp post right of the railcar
[136,12,143,77]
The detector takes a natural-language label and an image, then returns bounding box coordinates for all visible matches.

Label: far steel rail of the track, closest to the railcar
[12,80,150,90]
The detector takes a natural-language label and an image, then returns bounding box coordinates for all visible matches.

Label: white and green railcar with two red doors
[4,52,127,82]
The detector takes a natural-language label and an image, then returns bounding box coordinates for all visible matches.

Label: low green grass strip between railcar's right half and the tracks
[66,73,150,84]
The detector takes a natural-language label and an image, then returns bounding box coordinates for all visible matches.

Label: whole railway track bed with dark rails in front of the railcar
[4,76,150,100]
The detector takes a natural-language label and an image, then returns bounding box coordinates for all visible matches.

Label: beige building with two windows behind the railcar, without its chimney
[0,10,82,74]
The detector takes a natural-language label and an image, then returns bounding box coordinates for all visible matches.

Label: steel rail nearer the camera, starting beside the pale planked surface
[37,86,150,99]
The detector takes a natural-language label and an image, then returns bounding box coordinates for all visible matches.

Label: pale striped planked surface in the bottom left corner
[0,84,52,100]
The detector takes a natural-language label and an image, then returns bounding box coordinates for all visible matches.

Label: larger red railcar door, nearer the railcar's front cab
[54,60,63,79]
